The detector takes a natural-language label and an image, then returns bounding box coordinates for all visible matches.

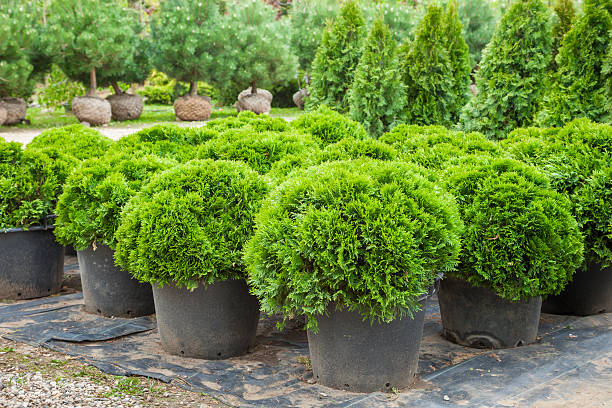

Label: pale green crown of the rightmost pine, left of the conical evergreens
[213,1,298,103]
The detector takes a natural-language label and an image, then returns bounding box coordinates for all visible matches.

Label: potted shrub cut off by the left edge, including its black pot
[0,138,76,299]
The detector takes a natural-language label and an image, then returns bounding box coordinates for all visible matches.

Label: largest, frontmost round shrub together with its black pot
[245,159,462,392]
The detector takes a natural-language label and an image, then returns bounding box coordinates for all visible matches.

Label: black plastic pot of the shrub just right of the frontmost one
[438,277,542,348]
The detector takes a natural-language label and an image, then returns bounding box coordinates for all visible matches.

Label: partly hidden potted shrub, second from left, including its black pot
[55,149,176,317]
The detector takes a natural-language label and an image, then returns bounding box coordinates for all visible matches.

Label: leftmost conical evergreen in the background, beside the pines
[306,0,365,112]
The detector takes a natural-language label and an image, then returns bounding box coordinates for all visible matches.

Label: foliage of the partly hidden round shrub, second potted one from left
[55,151,177,250]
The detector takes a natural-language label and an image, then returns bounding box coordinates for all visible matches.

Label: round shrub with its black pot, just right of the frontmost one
[438,157,583,348]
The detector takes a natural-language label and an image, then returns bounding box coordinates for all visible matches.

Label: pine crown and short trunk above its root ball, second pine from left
[47,0,140,95]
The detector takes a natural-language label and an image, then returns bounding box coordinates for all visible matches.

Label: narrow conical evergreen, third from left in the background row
[400,5,456,126]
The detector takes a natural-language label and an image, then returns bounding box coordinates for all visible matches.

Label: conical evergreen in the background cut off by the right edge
[538,0,612,126]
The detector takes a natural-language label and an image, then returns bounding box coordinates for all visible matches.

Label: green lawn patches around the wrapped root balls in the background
[10,105,302,129]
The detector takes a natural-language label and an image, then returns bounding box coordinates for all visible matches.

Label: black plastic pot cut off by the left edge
[0,226,64,300]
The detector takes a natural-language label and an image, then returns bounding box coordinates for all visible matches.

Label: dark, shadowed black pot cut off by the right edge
[542,263,612,316]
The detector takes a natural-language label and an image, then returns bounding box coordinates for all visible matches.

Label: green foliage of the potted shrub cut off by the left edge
[0,138,77,229]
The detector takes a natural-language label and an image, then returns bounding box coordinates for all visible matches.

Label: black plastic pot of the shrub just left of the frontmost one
[153,280,259,360]
